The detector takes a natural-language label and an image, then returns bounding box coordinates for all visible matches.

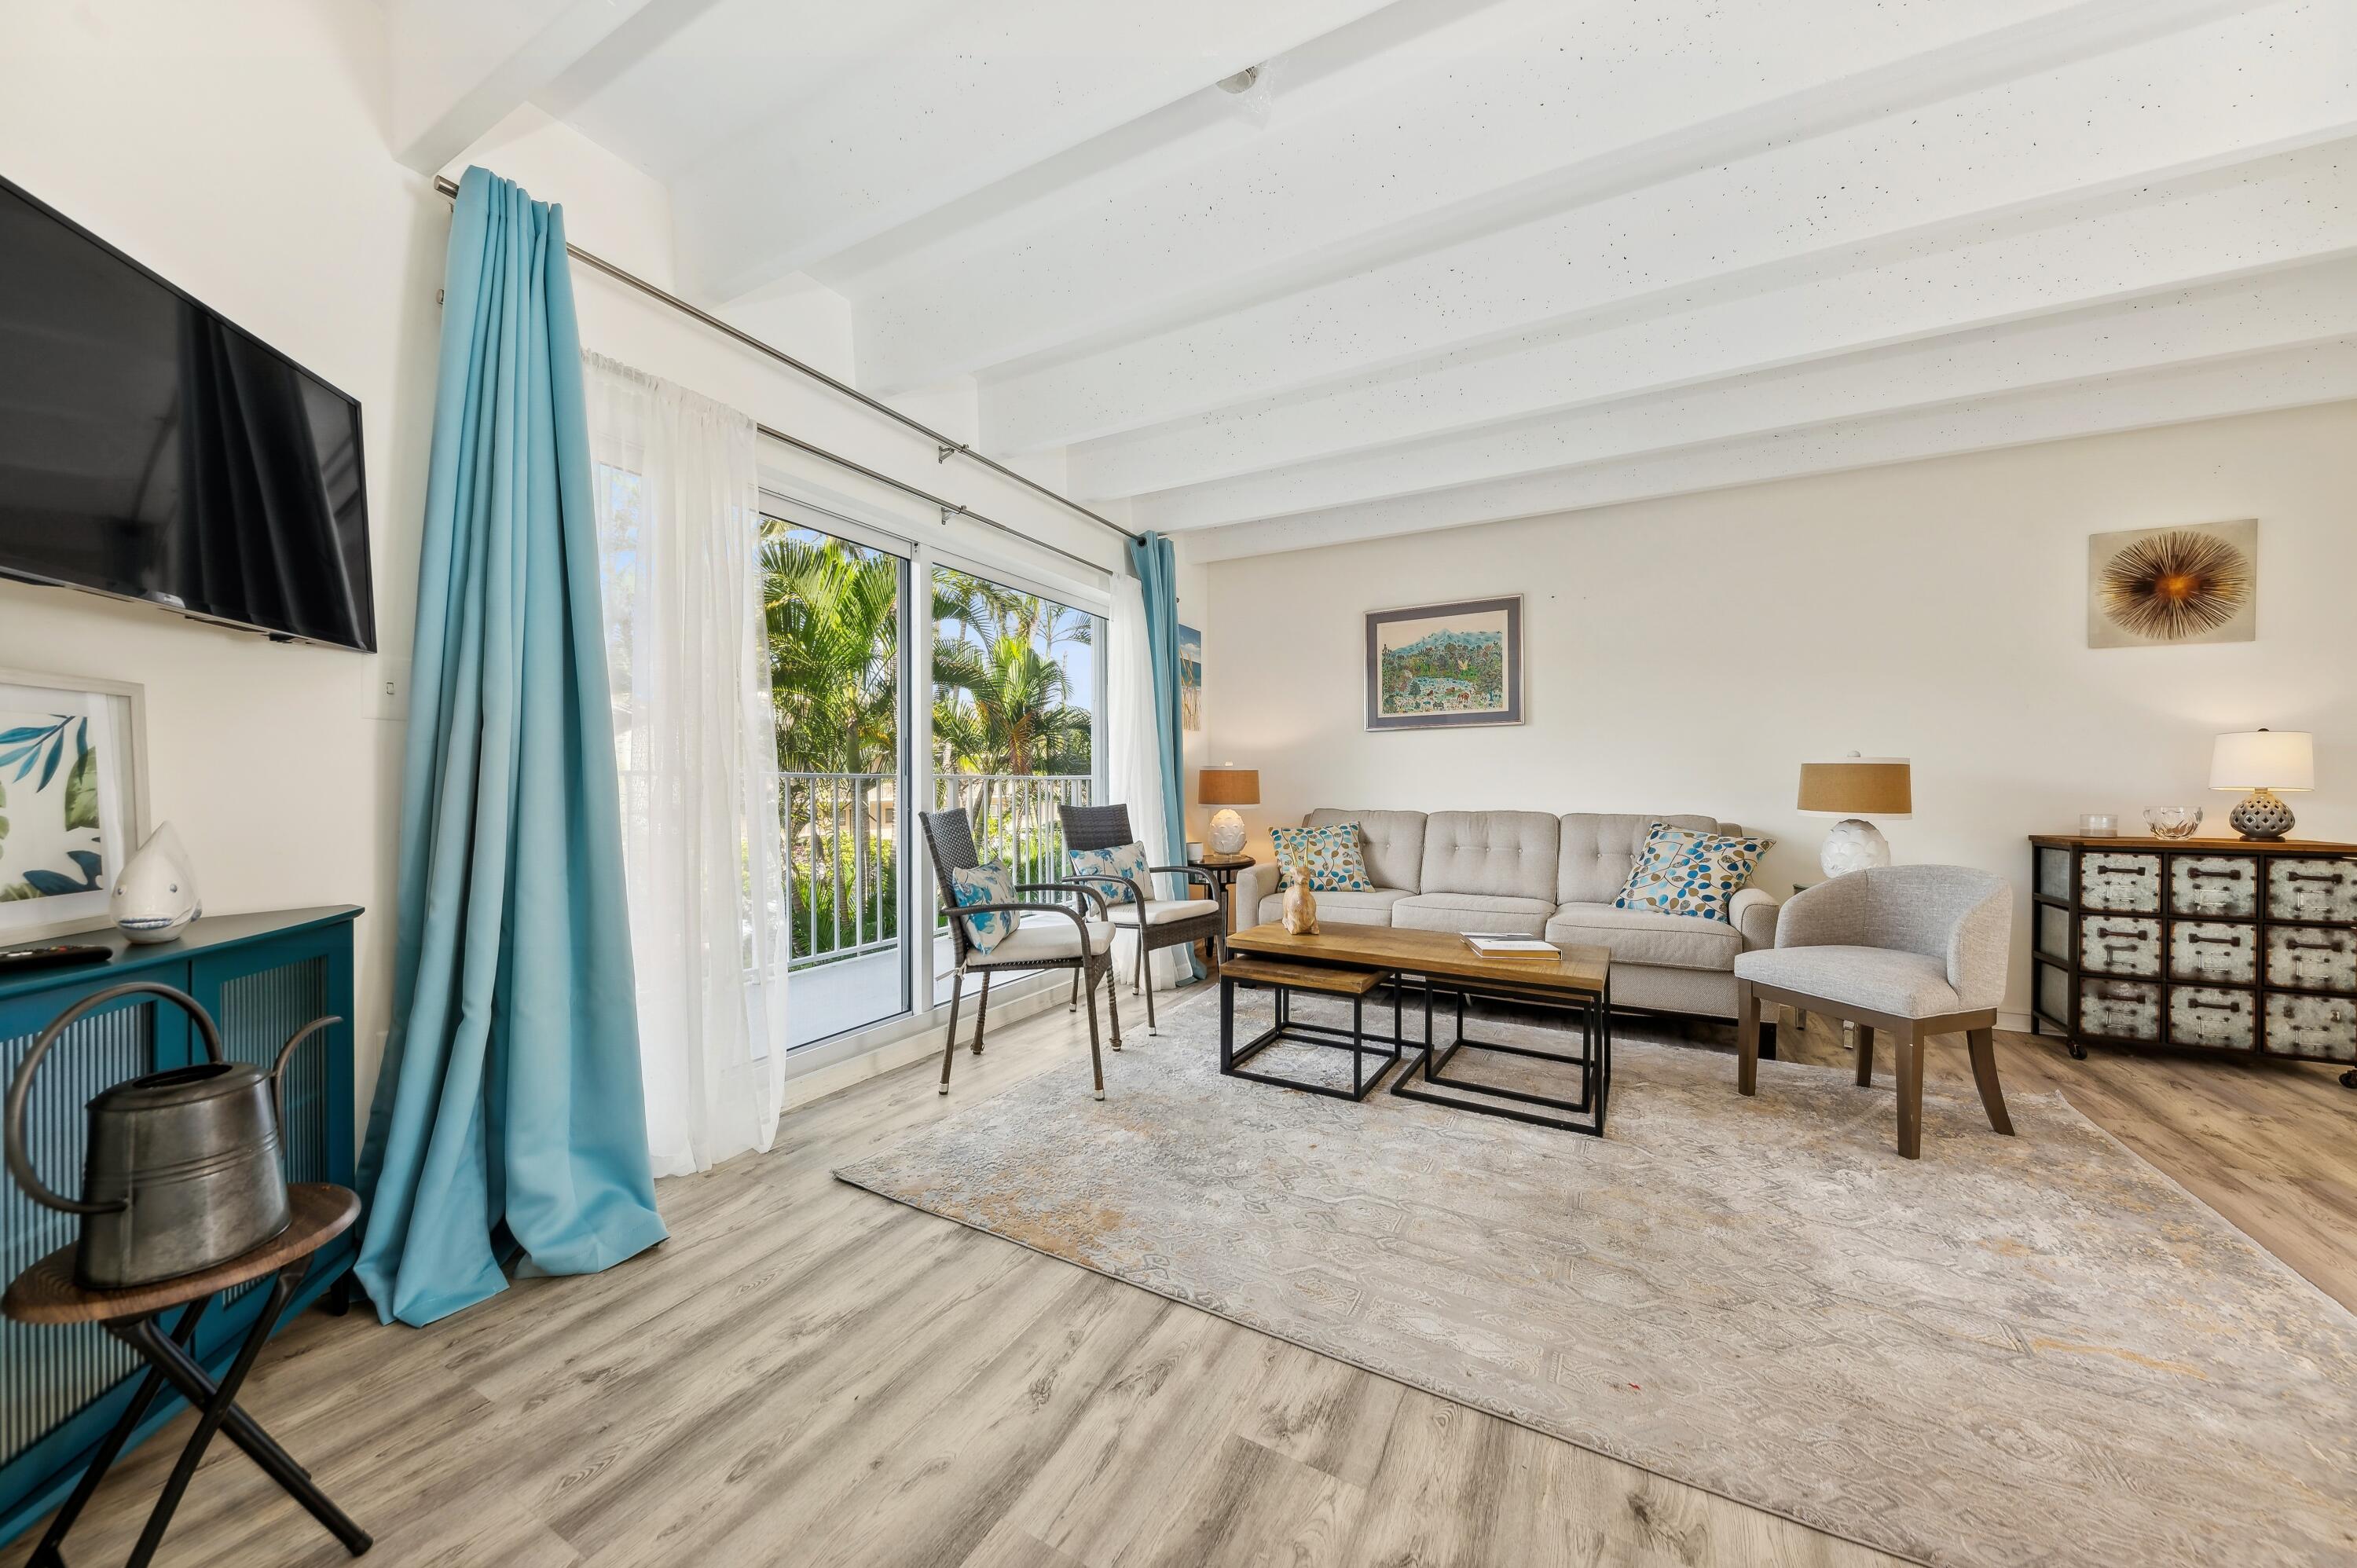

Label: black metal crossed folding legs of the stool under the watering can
[26,1259,375,1568]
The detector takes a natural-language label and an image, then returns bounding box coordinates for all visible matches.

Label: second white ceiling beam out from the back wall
[1131,259,2357,533]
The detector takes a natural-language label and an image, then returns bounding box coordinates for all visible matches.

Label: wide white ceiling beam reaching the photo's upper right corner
[983,5,2357,450]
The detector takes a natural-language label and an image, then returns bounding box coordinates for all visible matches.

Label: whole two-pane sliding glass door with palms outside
[761,495,1105,1050]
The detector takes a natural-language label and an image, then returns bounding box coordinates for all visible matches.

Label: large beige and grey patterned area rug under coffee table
[837,998,2357,1568]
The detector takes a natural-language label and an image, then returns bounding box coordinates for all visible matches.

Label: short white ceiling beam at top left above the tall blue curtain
[387,0,648,174]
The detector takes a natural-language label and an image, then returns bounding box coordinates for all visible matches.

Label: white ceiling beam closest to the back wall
[1190,337,2357,561]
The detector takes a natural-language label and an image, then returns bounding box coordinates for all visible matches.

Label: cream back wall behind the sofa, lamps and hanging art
[1204,403,2357,1014]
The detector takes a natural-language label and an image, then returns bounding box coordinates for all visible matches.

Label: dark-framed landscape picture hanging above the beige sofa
[1367,594,1523,728]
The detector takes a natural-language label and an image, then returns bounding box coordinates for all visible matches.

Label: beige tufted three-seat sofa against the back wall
[1233,811,1777,1019]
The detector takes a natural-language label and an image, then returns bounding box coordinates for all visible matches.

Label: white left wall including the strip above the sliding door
[0,0,1120,1104]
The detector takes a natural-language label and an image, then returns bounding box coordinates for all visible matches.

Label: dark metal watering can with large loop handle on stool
[7,981,342,1290]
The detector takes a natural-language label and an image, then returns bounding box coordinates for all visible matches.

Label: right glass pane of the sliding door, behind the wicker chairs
[929,561,1105,1002]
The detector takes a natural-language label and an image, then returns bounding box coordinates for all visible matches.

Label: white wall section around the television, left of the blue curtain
[0,0,448,1098]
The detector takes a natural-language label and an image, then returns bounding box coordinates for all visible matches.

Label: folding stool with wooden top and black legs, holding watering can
[0,1181,375,1568]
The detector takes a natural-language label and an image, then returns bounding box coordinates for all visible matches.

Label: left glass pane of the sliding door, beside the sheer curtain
[761,509,931,1045]
